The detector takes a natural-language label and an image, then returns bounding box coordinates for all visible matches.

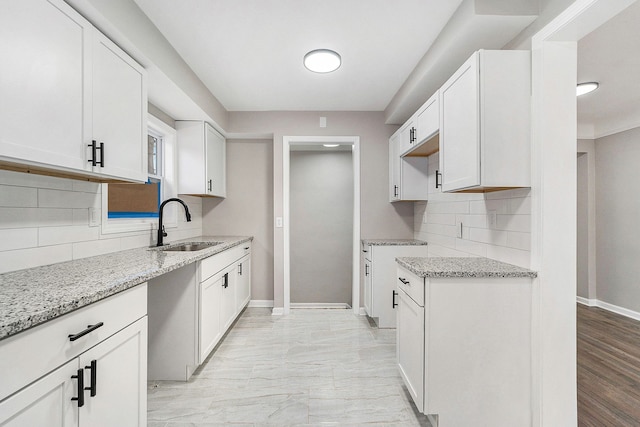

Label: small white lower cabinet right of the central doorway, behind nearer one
[363,244,428,328]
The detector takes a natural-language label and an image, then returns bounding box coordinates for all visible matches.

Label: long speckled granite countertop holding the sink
[0,236,253,340]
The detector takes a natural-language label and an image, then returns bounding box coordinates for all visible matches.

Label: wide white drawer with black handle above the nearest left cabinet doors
[0,283,147,400]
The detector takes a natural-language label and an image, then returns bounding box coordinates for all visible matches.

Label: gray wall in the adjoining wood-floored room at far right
[595,128,640,311]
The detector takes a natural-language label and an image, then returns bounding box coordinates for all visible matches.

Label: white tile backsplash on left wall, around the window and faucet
[0,170,202,273]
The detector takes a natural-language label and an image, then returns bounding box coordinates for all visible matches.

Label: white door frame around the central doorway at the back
[282,136,360,315]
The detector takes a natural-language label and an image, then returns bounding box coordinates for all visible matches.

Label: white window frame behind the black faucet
[100,114,178,234]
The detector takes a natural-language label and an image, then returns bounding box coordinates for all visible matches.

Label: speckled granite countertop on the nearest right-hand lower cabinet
[396,257,538,278]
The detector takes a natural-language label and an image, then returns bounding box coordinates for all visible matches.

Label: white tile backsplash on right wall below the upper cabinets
[414,153,531,268]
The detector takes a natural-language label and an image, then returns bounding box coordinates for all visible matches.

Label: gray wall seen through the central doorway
[290,151,353,305]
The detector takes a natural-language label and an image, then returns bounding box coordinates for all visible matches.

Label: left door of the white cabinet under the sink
[199,274,225,363]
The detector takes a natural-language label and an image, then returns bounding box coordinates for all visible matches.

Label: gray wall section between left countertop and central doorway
[202,139,273,300]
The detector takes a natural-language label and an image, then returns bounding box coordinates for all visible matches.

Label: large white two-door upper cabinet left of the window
[0,0,147,181]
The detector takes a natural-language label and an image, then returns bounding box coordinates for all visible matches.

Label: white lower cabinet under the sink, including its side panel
[148,242,251,381]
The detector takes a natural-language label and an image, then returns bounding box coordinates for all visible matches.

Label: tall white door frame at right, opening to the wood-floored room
[531,0,636,426]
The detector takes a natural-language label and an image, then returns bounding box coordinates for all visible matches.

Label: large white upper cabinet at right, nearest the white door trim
[439,50,531,192]
